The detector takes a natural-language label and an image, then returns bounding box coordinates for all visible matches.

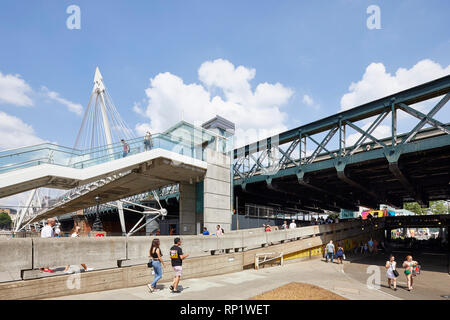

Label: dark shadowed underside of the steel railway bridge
[235,144,450,211]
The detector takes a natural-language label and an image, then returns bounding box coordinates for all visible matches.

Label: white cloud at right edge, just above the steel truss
[341,59,450,111]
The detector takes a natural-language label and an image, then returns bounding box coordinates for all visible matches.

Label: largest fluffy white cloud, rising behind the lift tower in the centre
[133,59,293,146]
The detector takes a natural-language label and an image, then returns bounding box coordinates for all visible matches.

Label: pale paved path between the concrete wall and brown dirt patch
[48,259,399,300]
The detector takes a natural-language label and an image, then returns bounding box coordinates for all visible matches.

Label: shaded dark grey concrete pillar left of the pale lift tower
[179,183,197,235]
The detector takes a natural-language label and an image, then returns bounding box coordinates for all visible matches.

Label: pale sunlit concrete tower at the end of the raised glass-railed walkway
[203,149,232,233]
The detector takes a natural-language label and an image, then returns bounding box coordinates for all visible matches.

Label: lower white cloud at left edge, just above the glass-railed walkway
[0,111,45,150]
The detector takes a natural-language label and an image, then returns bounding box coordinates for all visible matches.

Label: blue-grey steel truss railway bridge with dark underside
[233,76,450,211]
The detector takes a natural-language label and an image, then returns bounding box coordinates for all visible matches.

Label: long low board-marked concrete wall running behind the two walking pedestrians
[0,222,383,299]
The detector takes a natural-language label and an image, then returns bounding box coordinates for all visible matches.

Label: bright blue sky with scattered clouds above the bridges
[0,0,450,149]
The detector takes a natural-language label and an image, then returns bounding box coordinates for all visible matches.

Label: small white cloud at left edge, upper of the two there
[0,72,33,107]
